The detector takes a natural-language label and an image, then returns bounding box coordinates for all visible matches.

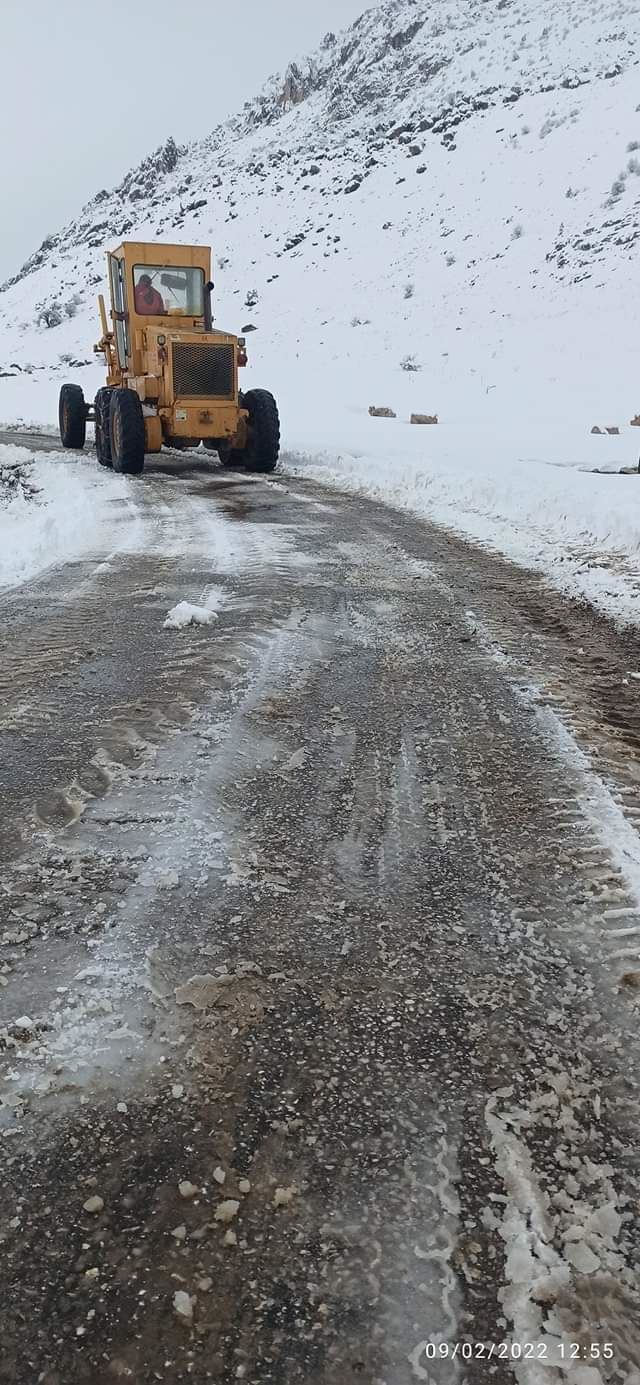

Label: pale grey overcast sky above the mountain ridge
[0,0,374,283]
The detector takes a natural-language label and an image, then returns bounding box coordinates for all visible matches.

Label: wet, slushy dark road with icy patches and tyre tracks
[0,438,640,1385]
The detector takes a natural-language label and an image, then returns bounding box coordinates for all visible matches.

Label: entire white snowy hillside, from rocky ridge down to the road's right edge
[0,0,640,614]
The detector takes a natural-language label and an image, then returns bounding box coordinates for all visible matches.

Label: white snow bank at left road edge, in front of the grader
[0,445,127,587]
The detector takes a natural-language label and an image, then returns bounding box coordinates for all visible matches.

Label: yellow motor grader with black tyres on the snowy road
[60,241,280,474]
